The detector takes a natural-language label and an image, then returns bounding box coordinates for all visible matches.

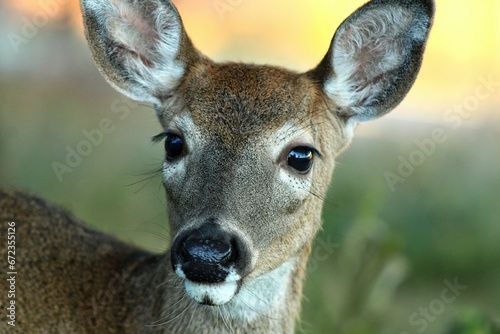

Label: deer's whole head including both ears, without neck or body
[82,0,434,305]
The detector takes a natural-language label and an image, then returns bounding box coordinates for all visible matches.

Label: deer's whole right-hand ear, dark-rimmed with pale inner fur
[310,0,434,132]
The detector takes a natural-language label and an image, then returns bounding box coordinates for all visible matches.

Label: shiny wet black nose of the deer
[171,220,249,283]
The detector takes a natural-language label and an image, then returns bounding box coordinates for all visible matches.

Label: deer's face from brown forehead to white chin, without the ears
[160,64,345,304]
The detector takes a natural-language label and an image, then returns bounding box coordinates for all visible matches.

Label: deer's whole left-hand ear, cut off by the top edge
[81,0,202,105]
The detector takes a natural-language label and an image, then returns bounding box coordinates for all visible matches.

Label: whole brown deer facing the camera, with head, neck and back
[0,0,435,333]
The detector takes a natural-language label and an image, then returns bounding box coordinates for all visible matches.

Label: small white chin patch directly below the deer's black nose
[184,279,238,305]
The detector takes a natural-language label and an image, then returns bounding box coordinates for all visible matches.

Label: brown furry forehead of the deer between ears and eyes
[168,64,322,148]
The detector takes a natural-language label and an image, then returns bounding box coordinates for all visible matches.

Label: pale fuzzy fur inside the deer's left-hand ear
[85,0,185,104]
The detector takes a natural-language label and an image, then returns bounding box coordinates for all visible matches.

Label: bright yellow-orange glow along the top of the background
[10,0,500,120]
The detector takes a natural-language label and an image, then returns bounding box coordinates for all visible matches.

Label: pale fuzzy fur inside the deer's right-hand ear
[325,6,414,121]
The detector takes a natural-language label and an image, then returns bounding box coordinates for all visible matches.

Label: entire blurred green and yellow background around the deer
[0,0,500,334]
